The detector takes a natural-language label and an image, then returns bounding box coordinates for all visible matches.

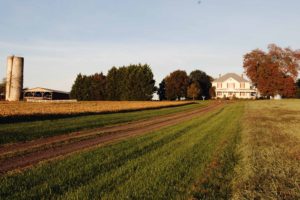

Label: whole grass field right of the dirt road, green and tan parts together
[0,100,300,199]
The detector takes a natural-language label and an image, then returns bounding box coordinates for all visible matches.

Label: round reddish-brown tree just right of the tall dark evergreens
[165,70,189,100]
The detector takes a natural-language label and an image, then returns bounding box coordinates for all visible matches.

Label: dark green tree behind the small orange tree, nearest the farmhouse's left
[189,70,212,99]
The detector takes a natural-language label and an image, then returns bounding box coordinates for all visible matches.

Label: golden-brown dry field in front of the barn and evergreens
[0,101,191,117]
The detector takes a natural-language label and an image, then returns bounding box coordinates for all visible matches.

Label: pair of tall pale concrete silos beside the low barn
[5,56,24,101]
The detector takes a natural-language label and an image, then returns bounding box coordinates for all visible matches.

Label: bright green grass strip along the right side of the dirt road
[0,103,244,199]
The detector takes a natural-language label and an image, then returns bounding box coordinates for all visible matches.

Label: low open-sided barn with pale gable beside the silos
[23,87,70,101]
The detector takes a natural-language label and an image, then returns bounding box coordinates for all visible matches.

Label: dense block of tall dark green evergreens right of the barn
[70,64,156,101]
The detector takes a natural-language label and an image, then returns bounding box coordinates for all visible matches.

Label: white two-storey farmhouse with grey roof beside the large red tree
[212,73,257,99]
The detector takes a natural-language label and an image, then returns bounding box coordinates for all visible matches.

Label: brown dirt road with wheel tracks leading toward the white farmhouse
[0,102,223,173]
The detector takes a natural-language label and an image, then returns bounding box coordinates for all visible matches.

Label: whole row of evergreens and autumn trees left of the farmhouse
[70,64,214,101]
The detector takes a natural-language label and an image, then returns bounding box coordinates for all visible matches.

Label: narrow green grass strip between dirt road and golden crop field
[0,101,206,144]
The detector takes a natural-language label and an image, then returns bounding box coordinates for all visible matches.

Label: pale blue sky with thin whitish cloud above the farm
[0,0,300,91]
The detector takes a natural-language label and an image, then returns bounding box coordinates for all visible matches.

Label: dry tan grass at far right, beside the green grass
[233,100,300,199]
